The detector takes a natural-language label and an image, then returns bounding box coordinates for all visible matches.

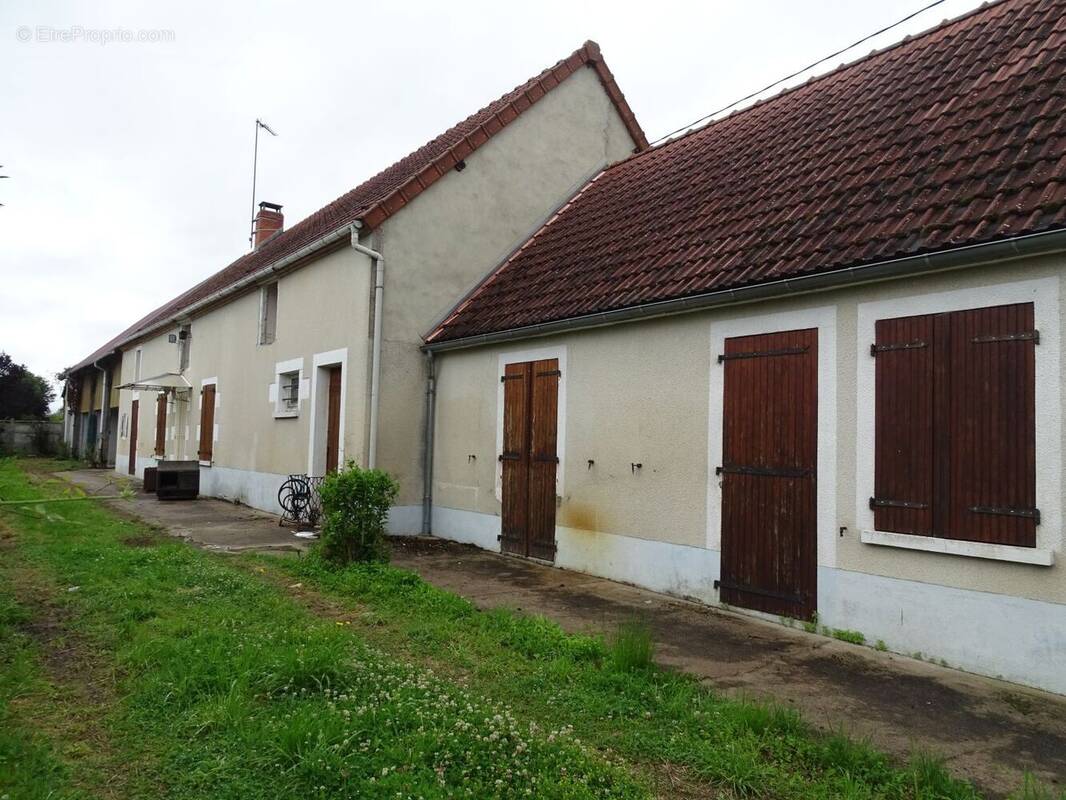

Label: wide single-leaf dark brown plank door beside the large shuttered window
[717,330,818,620]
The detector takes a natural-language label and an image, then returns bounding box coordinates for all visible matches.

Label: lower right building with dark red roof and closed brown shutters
[420,0,1066,692]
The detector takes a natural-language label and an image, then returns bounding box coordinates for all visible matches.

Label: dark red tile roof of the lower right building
[427,0,1066,341]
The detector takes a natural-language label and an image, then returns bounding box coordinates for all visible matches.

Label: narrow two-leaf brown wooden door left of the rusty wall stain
[500,358,561,561]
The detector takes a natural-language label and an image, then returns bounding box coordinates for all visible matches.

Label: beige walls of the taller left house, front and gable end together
[98,68,634,514]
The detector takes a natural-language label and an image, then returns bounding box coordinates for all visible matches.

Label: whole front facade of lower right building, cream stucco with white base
[433,255,1066,691]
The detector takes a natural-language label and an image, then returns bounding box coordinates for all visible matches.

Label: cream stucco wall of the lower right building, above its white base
[434,257,1066,603]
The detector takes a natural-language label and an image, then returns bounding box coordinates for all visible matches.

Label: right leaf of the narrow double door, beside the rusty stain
[529,358,560,561]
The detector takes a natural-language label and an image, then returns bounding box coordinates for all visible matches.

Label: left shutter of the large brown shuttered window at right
[871,315,935,535]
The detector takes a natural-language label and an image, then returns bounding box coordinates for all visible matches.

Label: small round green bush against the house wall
[319,461,400,564]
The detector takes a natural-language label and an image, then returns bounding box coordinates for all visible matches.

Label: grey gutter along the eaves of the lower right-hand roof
[422,229,1066,353]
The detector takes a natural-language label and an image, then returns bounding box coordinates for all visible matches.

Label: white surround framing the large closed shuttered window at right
[855,276,1063,566]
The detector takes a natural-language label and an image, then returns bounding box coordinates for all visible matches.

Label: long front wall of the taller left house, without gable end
[117,247,371,508]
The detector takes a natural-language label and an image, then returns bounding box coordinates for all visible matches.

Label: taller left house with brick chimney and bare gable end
[65,42,647,520]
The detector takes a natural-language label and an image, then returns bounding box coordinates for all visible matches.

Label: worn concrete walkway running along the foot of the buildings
[62,470,1066,795]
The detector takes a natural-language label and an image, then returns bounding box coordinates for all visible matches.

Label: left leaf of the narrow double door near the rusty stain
[500,362,533,556]
